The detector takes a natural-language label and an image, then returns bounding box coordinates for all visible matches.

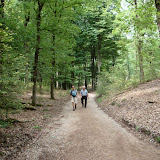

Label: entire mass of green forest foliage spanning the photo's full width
[0,0,160,115]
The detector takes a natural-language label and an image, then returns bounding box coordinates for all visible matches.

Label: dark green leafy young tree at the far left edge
[0,24,23,117]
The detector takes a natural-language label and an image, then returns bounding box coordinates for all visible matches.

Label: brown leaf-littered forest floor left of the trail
[0,91,68,160]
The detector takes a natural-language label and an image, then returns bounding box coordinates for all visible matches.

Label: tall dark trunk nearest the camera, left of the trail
[32,0,44,106]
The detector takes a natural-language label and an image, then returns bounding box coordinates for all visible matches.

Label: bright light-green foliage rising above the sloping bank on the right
[97,2,160,94]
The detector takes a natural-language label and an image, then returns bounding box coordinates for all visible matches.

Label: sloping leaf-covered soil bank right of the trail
[99,80,160,147]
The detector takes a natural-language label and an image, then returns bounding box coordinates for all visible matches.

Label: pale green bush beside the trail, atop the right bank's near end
[96,67,140,95]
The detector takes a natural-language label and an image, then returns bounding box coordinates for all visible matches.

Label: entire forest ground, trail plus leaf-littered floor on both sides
[0,80,160,160]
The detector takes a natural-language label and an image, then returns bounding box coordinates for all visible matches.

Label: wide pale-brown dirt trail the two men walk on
[16,94,160,160]
